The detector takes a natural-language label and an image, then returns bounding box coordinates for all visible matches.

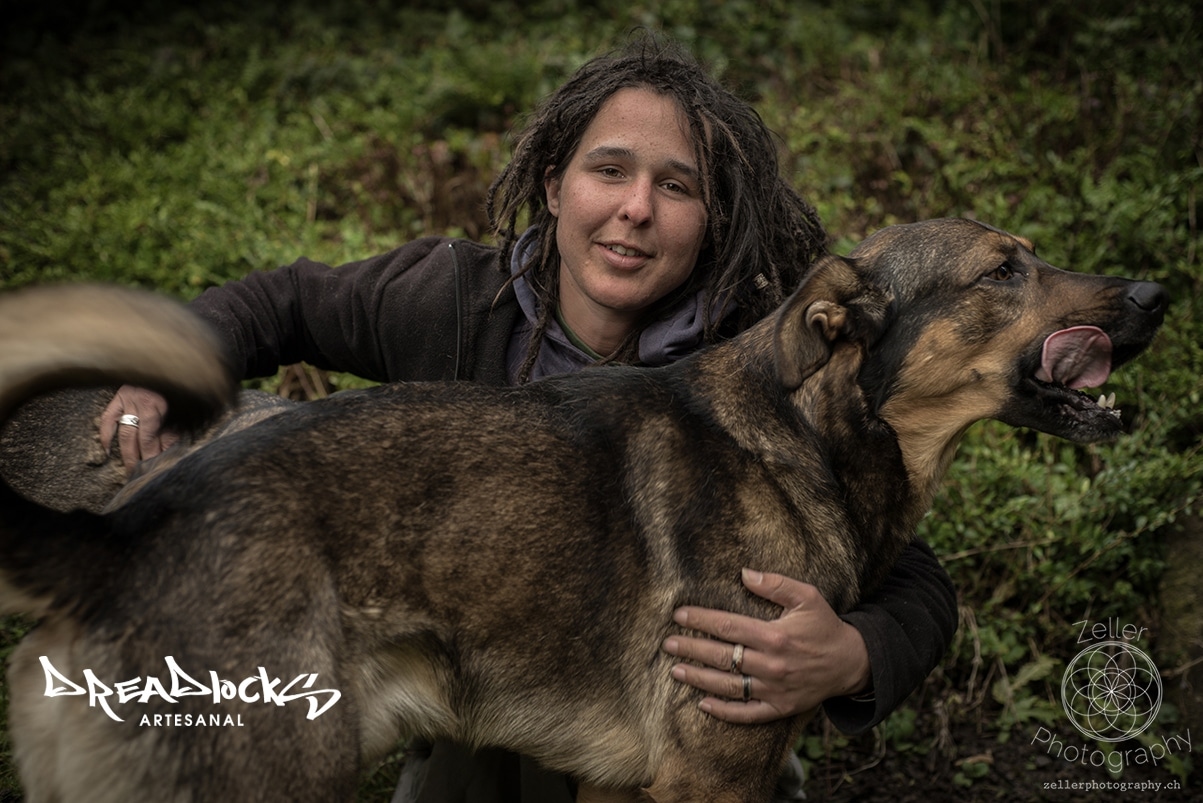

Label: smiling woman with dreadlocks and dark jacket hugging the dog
[101,41,955,802]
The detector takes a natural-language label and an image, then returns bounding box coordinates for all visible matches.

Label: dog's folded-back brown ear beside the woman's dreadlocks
[774,254,885,390]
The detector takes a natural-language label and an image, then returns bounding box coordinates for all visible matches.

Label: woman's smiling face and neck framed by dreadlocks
[545,88,706,354]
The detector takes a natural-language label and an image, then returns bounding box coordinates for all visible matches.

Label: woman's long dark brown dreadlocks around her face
[487,36,826,382]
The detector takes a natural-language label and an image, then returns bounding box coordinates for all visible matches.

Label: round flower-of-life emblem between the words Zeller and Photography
[1061,642,1162,742]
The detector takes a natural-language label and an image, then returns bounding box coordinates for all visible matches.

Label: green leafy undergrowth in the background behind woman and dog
[0,0,1203,799]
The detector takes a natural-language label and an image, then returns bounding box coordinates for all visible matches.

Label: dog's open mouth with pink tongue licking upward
[1027,326,1122,441]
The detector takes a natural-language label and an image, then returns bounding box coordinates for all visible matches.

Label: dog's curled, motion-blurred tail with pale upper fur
[0,284,236,614]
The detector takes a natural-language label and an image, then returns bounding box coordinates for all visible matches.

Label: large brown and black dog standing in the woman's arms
[0,219,1167,803]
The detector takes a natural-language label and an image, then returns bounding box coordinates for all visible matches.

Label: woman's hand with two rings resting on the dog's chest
[663,569,872,725]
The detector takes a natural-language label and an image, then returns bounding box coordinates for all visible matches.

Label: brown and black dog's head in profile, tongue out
[776,220,1167,496]
